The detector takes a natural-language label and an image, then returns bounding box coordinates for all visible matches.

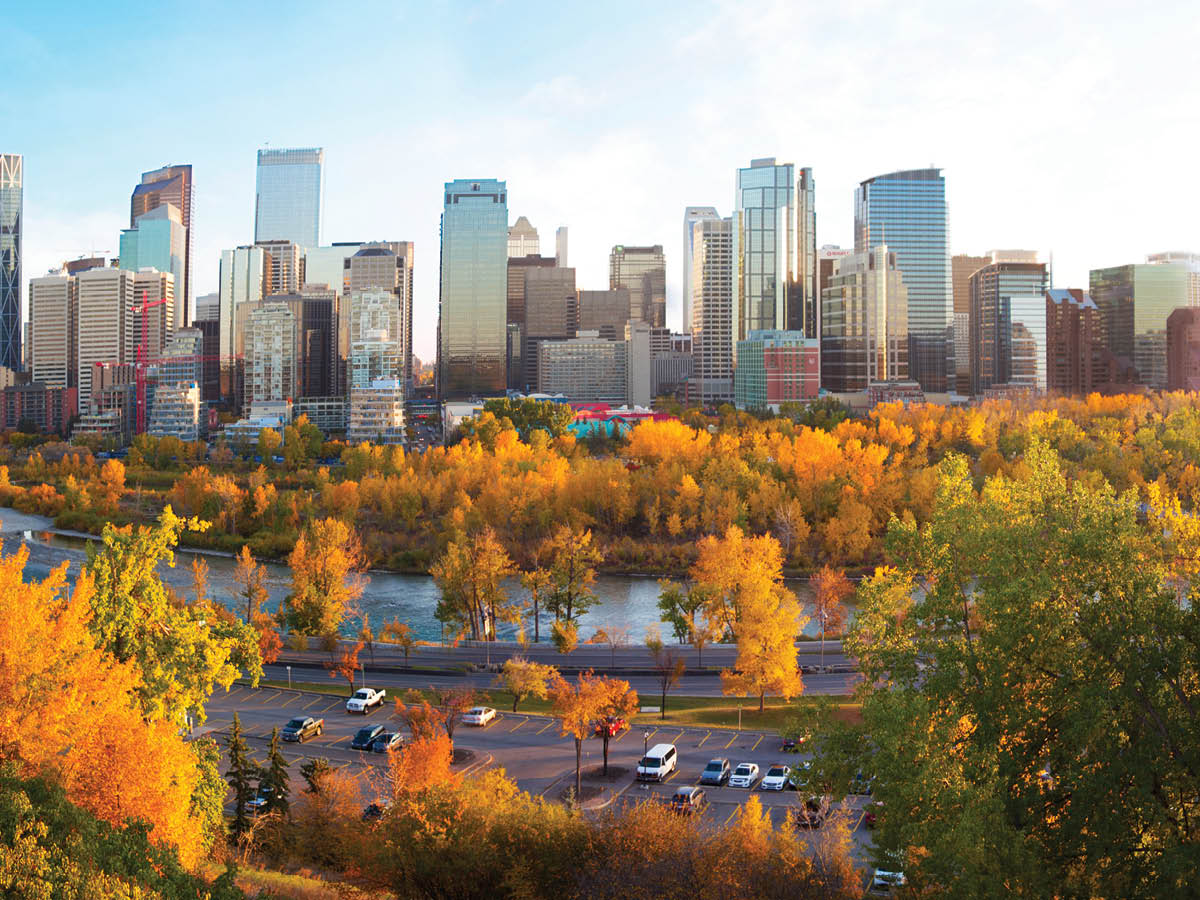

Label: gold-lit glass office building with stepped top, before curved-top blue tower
[821,245,911,392]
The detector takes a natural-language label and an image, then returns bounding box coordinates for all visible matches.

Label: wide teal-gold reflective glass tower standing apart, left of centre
[438,179,509,400]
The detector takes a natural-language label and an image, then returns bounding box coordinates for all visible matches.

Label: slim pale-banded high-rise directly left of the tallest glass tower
[690,218,737,404]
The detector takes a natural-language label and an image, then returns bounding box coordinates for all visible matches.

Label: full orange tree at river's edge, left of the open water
[281,518,366,635]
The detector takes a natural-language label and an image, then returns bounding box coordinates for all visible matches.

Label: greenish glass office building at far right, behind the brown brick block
[1088,253,1200,389]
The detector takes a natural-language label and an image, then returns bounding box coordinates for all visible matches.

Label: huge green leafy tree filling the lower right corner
[847,446,1200,898]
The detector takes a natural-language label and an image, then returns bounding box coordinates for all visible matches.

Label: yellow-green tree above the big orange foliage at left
[84,506,263,727]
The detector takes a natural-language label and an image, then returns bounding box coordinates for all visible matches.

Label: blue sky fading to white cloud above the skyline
[9,0,1200,359]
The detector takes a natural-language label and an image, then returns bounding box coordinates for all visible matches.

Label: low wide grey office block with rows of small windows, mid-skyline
[538,331,629,404]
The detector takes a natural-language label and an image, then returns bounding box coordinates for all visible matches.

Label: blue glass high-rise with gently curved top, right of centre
[854,168,958,392]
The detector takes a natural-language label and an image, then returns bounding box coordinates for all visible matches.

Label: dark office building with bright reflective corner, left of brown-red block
[967,251,1050,395]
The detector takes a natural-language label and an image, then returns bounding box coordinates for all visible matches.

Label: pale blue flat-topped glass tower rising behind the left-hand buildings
[254,148,325,247]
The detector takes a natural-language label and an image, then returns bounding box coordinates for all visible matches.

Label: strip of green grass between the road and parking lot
[241,679,862,731]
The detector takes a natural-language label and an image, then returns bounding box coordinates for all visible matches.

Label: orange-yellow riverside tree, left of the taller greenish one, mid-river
[431,528,521,641]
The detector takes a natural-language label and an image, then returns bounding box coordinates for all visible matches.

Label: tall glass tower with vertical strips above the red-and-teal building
[732,156,796,340]
